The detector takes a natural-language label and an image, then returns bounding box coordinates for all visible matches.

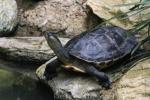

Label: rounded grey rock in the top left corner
[0,0,18,36]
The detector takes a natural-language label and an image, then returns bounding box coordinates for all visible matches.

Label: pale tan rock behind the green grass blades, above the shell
[86,0,150,29]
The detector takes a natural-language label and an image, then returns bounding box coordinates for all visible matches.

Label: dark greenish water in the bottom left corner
[0,69,53,100]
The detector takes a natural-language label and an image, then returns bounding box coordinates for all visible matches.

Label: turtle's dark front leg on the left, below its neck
[44,57,61,80]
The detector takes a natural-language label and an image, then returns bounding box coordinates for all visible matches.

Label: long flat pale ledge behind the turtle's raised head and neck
[0,37,69,64]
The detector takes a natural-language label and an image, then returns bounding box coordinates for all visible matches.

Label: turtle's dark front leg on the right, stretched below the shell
[86,66,111,89]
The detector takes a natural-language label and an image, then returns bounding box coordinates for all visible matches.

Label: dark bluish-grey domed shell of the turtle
[65,26,137,68]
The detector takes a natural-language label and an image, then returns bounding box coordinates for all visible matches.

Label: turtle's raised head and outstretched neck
[44,32,70,64]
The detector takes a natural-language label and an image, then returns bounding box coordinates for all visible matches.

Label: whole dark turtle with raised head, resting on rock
[44,26,137,88]
